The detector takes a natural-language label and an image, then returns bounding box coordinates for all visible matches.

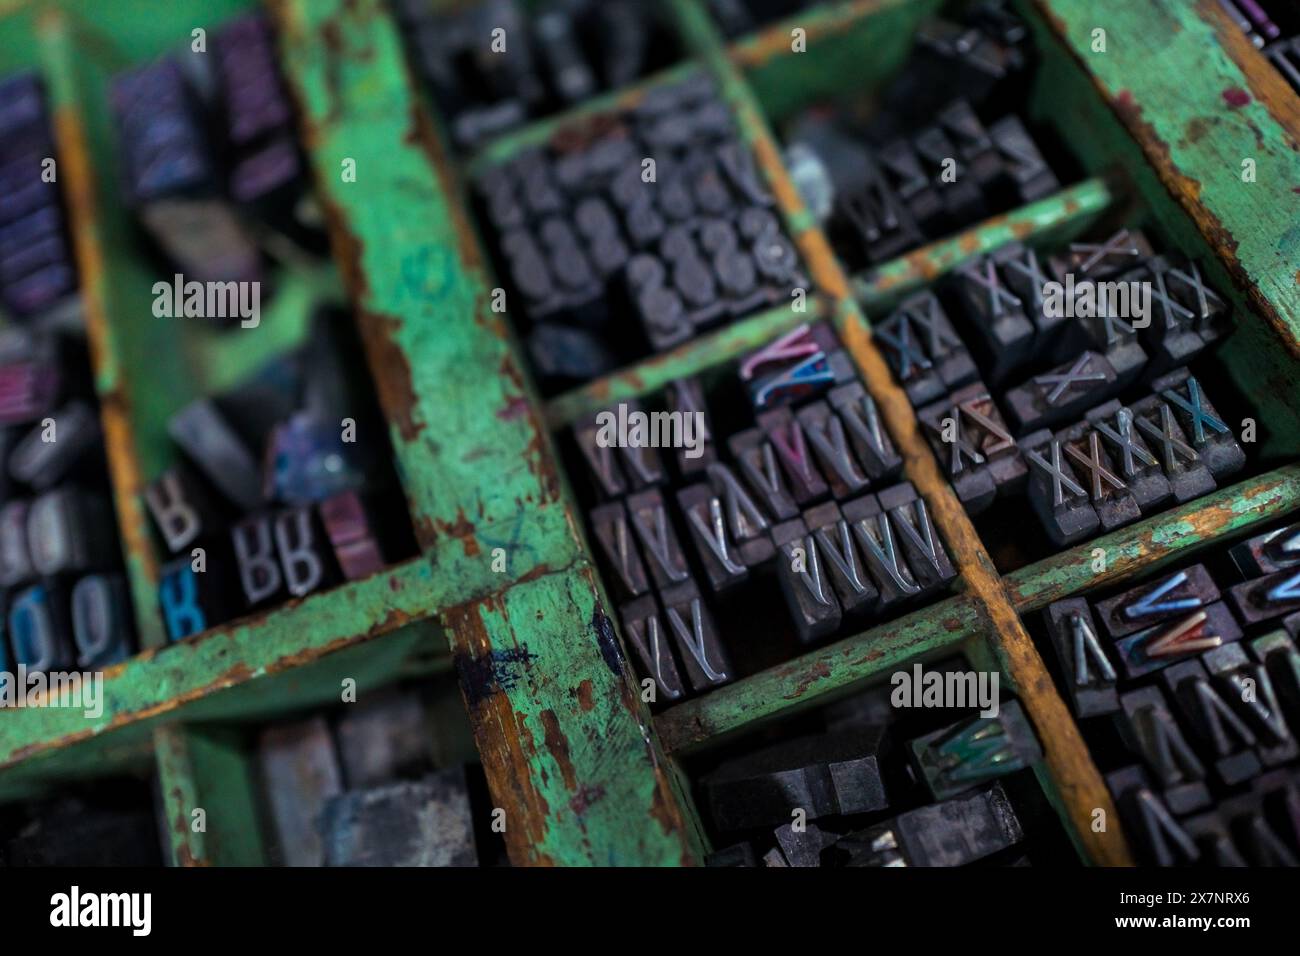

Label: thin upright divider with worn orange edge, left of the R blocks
[38,8,166,648]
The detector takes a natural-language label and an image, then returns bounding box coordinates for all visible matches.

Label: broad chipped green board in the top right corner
[1040,0,1300,355]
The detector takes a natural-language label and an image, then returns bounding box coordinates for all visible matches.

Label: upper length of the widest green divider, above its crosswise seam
[270,0,581,606]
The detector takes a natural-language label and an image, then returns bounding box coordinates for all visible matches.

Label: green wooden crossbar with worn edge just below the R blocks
[0,558,436,773]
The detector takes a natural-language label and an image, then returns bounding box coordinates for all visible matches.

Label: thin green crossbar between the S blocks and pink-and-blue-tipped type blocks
[546,295,829,431]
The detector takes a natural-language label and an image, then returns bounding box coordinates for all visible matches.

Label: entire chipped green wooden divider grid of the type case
[0,0,1300,865]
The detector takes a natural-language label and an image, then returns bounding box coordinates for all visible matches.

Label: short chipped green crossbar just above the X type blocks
[854,178,1115,315]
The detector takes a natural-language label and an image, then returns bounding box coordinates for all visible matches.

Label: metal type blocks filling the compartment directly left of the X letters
[575,323,956,701]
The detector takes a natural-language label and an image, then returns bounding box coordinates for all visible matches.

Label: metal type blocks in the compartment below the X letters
[1045,525,1300,866]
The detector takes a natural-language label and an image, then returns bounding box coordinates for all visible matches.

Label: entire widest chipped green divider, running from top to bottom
[270,0,701,865]
